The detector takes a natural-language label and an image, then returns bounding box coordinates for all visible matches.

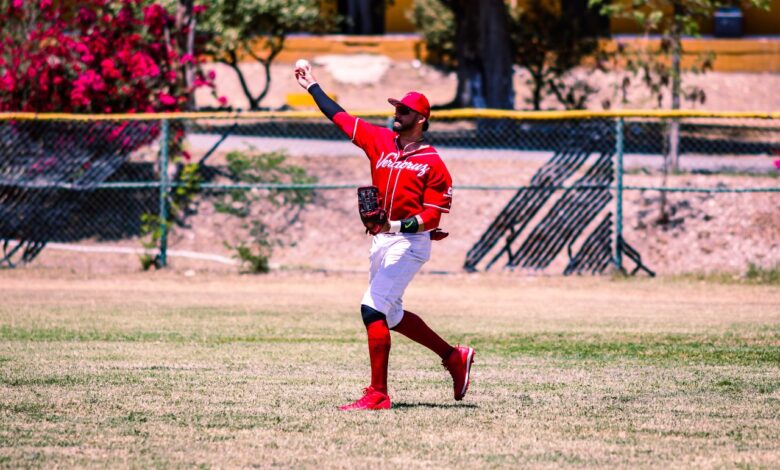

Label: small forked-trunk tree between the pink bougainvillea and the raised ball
[197,0,334,110]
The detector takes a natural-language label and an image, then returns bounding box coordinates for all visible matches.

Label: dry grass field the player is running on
[0,270,780,468]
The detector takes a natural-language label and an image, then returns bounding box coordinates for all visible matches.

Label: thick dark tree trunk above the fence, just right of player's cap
[448,0,514,109]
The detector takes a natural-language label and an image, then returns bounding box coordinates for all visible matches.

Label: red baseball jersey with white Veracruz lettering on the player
[333,112,452,226]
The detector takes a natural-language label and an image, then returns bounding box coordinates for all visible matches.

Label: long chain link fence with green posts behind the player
[0,110,780,273]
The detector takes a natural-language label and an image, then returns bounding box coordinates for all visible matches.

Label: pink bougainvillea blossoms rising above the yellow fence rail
[0,0,213,113]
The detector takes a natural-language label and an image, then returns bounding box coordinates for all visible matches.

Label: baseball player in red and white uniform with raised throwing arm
[295,60,474,410]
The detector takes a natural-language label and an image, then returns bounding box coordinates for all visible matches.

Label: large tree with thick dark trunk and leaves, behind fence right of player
[409,0,606,110]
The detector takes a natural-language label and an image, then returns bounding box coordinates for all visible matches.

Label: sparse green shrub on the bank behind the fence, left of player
[215,151,317,273]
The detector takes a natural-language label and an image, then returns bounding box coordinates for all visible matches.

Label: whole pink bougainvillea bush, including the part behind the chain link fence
[0,0,214,272]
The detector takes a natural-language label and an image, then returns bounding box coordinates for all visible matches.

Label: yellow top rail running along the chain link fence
[0,109,780,121]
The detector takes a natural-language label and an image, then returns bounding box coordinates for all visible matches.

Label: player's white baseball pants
[362,232,431,328]
